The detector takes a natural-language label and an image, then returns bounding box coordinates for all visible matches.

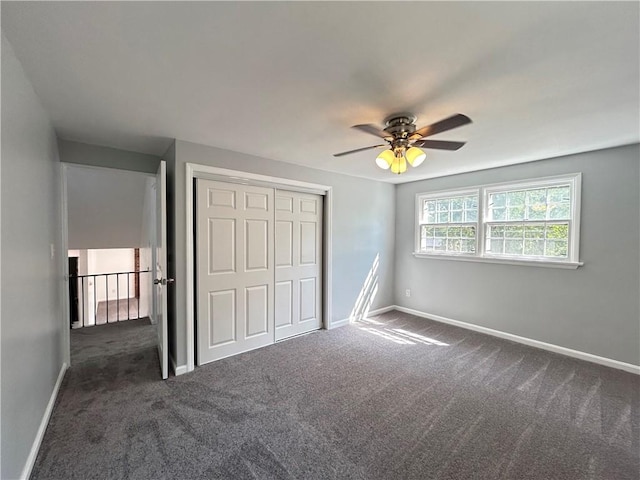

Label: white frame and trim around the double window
[413,173,583,269]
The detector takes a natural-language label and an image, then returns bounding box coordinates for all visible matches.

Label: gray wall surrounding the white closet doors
[165,140,395,365]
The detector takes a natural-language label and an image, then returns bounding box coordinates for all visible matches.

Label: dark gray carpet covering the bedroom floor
[32,312,640,480]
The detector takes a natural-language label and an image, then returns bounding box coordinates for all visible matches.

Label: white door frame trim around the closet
[185,163,333,372]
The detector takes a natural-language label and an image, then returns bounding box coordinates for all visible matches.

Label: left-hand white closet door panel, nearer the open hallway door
[196,179,274,365]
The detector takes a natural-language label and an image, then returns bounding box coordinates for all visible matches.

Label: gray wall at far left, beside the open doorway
[0,36,66,479]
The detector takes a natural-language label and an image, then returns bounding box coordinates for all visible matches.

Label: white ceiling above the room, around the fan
[2,2,640,183]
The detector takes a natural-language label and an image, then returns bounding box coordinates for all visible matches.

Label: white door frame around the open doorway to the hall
[60,162,168,367]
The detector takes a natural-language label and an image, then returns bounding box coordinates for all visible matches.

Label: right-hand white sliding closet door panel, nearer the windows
[275,190,322,340]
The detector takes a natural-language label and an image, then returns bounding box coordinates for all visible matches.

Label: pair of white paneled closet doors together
[196,179,322,365]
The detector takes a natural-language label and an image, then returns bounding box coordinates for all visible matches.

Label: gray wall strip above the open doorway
[58,139,160,174]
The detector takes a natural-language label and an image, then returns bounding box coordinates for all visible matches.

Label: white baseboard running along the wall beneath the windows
[393,305,640,375]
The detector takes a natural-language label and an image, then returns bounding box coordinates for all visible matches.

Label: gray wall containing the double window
[395,145,640,365]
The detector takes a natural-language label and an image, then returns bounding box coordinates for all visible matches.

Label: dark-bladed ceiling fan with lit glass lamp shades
[333,113,471,175]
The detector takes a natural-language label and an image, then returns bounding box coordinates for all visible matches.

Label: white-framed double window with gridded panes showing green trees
[415,174,581,268]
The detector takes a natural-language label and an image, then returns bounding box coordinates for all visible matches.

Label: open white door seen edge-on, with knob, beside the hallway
[153,161,168,379]
